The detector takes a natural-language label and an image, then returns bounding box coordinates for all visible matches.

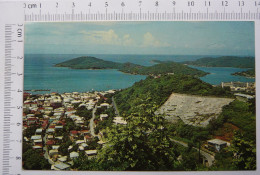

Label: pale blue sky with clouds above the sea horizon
[25,22,255,56]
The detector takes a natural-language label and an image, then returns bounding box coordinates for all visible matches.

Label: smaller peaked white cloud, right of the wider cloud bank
[142,32,170,47]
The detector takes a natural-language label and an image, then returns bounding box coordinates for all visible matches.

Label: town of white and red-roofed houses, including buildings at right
[23,82,255,170]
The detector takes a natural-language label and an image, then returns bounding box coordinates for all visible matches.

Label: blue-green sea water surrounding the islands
[24,54,255,93]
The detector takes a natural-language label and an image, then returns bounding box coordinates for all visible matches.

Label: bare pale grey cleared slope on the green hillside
[156,93,234,127]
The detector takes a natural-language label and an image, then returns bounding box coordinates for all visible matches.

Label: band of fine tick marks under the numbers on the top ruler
[25,11,260,22]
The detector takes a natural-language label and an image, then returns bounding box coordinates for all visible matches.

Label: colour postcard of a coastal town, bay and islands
[22,21,256,172]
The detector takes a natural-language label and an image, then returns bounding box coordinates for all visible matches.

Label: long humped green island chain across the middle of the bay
[55,56,208,77]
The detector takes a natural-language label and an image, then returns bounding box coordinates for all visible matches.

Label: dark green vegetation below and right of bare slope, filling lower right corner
[168,99,256,170]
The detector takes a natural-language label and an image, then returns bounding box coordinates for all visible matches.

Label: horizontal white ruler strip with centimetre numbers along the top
[23,0,260,22]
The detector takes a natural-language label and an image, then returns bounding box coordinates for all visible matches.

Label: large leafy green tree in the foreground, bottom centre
[98,97,179,170]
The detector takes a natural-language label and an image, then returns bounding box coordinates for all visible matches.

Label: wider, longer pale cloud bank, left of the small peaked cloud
[79,29,133,46]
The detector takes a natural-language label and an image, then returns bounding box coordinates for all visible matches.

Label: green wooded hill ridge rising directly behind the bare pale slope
[115,75,232,114]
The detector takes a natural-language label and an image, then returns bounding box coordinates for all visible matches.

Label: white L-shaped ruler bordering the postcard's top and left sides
[0,0,260,175]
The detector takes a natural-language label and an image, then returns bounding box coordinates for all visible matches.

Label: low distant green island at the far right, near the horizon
[183,56,255,68]
